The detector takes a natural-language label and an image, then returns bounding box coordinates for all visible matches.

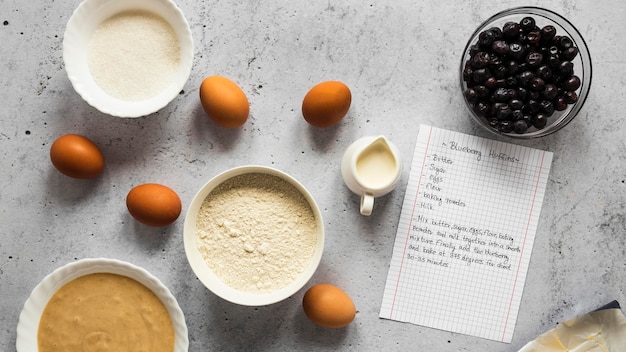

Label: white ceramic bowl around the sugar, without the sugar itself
[63,0,193,117]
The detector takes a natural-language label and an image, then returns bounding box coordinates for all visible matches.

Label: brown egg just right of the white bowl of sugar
[200,76,250,128]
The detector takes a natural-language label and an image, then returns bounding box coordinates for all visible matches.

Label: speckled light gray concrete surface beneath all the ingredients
[0,0,626,352]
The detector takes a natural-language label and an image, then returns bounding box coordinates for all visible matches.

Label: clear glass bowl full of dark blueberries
[460,7,591,139]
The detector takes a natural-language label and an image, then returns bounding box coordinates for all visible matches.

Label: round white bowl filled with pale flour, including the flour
[184,165,324,306]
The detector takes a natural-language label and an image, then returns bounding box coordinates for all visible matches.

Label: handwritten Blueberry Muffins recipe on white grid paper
[380,125,552,343]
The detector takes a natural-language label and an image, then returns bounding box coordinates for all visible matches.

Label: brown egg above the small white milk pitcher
[302,81,352,127]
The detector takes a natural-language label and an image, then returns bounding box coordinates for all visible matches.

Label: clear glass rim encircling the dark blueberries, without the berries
[459,6,593,139]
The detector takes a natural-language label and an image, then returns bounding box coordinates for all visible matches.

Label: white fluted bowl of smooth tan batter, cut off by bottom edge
[16,258,189,352]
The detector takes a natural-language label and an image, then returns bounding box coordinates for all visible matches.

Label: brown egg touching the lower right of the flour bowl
[302,284,356,328]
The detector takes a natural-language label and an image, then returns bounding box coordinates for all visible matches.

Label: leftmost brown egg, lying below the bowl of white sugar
[50,134,104,179]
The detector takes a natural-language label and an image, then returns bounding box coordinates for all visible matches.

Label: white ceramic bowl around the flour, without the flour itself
[184,165,324,306]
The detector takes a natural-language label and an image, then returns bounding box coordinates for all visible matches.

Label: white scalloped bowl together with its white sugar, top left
[63,0,193,117]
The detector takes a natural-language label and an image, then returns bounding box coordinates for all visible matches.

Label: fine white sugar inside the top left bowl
[88,11,180,101]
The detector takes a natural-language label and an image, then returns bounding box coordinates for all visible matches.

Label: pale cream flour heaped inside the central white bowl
[196,173,318,293]
